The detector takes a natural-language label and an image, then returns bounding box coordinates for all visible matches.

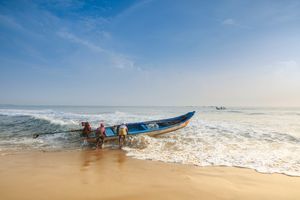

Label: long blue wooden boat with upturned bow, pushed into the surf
[88,111,195,142]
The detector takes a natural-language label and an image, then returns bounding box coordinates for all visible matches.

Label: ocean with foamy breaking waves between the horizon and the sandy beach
[0,105,300,176]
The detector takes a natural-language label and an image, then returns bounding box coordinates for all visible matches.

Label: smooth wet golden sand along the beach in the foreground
[0,150,300,200]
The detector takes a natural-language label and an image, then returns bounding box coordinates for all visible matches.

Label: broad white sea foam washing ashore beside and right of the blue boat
[124,113,300,176]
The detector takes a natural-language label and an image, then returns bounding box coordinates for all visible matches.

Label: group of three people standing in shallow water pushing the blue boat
[81,122,128,149]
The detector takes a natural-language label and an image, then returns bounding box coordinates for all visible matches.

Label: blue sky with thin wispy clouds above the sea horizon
[0,0,300,106]
